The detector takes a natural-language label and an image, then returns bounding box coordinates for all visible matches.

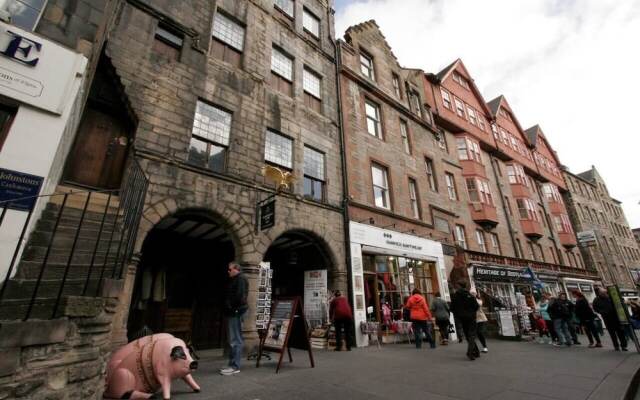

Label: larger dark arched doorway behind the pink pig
[127,210,235,349]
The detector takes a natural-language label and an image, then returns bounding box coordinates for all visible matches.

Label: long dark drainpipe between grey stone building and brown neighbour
[327,7,355,306]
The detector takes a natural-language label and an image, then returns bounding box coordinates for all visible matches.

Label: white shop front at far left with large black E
[0,22,87,281]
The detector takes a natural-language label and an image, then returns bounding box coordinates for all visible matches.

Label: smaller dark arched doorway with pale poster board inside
[264,230,335,327]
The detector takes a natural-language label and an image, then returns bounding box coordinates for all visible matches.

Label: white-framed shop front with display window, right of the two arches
[349,221,449,346]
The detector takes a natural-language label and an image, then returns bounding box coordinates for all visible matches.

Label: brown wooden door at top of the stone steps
[64,107,129,189]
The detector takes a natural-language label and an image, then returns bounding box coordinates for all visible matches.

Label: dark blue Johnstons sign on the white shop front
[0,168,44,211]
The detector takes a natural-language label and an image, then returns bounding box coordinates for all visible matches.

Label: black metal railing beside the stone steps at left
[0,159,149,320]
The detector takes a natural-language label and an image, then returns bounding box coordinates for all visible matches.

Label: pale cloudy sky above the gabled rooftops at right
[335,0,640,228]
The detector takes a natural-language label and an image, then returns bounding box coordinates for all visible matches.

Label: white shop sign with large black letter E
[0,22,87,115]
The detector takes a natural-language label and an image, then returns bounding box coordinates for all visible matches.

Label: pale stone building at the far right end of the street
[563,167,640,295]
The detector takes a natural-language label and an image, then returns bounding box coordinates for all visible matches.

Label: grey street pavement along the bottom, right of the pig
[172,340,640,400]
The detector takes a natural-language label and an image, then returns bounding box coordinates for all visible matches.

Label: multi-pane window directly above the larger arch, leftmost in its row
[188,101,231,172]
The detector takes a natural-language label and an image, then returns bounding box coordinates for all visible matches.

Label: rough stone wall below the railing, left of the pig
[0,280,122,400]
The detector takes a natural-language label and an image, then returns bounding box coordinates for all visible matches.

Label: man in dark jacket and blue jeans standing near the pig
[220,261,249,375]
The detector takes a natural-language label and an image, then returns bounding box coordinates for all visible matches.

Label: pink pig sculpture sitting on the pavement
[104,333,200,399]
